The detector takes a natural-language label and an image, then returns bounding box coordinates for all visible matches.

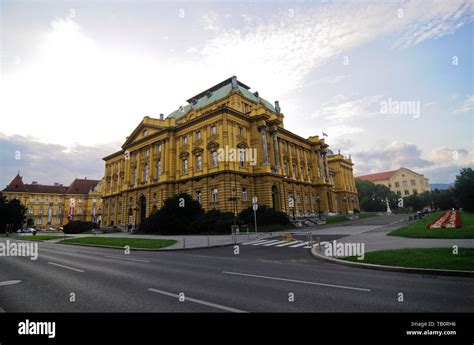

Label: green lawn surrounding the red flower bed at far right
[388,212,474,238]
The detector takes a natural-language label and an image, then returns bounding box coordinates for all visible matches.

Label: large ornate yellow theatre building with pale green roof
[103,76,359,226]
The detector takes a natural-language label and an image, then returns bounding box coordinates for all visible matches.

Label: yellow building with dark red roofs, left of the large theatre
[2,174,102,228]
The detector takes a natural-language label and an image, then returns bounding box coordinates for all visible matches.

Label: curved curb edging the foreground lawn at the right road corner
[311,246,474,278]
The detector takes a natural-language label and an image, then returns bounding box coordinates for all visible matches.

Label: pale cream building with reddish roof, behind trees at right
[357,167,431,197]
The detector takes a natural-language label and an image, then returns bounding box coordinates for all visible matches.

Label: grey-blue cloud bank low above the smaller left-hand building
[0,134,116,190]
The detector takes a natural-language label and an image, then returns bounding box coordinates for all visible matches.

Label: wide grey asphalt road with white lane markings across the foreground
[0,220,474,312]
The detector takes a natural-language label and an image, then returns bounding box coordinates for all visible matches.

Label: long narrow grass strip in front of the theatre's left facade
[60,237,177,249]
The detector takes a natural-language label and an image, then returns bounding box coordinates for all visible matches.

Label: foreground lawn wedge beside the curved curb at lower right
[343,248,474,271]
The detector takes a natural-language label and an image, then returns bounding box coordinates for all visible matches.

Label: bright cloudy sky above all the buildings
[0,0,474,187]
